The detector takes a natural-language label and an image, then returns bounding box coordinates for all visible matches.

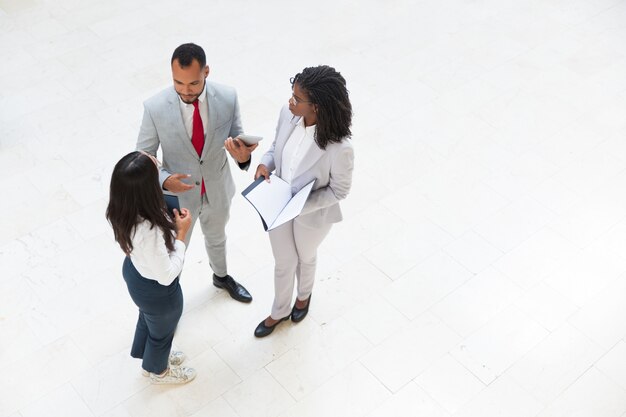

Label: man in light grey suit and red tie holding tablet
[137,43,257,302]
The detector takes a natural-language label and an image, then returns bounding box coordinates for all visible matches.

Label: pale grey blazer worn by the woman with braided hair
[260,106,354,227]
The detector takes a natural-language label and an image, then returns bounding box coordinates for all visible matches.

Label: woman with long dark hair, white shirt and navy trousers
[106,151,196,384]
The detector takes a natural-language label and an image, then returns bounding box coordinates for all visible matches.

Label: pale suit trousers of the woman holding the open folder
[269,217,332,320]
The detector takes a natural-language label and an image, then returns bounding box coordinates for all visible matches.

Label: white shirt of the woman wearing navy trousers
[130,220,185,285]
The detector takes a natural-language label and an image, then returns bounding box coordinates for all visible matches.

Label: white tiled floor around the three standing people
[0,0,626,417]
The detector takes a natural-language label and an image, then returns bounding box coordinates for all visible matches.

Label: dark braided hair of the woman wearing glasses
[291,65,352,149]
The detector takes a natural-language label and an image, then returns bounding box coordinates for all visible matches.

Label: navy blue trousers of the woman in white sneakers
[122,257,183,374]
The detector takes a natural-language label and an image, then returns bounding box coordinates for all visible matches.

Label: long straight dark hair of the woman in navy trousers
[106,151,176,255]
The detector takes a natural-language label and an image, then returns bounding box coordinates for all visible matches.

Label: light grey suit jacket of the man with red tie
[137,81,244,209]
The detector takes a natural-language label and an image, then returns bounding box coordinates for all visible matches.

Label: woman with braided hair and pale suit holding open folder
[254,65,354,337]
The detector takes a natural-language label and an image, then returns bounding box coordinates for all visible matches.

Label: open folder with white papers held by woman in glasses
[241,175,315,231]
